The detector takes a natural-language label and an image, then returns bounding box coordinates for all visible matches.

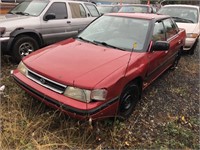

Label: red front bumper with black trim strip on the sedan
[13,70,119,120]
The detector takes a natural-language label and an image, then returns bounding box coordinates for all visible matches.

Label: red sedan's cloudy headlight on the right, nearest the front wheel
[64,86,107,103]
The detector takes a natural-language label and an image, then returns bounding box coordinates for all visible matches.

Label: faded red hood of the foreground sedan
[23,39,137,89]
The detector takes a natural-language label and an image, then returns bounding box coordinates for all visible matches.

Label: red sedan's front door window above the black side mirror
[152,22,166,41]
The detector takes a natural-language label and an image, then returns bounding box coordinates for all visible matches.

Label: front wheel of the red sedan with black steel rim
[118,82,141,119]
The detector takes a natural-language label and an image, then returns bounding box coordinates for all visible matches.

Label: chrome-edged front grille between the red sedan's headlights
[27,70,67,94]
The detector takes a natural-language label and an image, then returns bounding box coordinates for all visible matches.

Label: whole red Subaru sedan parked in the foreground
[13,13,185,119]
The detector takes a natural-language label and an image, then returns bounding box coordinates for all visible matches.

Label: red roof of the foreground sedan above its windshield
[106,12,170,20]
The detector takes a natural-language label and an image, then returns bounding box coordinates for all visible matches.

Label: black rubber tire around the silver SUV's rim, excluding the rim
[12,36,39,62]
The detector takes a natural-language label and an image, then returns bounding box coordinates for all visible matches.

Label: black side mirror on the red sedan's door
[151,41,170,51]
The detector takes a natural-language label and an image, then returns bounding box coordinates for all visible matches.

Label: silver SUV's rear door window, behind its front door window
[69,3,87,18]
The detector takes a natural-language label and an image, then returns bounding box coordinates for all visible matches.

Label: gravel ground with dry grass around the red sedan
[0,39,200,149]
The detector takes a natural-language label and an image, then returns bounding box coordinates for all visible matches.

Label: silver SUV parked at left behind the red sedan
[0,0,100,62]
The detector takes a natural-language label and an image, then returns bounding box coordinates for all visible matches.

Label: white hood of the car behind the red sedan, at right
[177,23,200,34]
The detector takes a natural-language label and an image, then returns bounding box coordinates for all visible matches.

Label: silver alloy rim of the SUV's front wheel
[19,42,34,57]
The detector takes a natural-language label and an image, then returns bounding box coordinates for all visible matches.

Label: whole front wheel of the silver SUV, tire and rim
[12,35,39,63]
